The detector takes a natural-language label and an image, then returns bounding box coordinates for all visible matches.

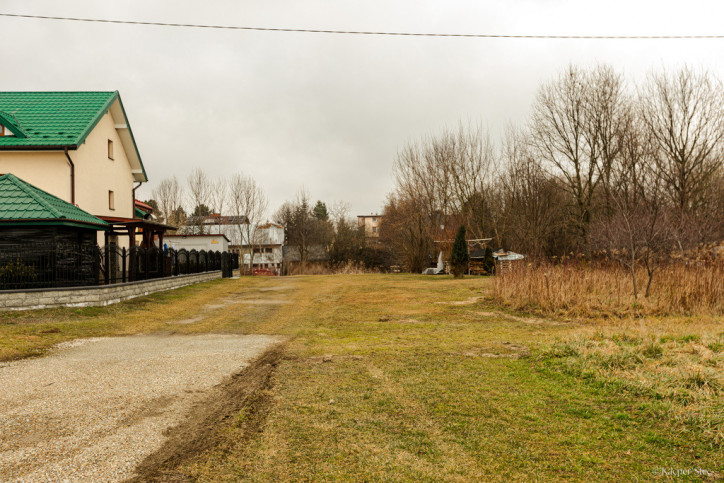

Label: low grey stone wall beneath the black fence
[0,270,221,310]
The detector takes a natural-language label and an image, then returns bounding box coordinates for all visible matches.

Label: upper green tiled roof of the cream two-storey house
[0,92,118,148]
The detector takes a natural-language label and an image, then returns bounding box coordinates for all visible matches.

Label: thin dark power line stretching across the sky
[0,13,724,40]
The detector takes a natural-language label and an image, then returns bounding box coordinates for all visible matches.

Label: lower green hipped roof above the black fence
[0,174,108,230]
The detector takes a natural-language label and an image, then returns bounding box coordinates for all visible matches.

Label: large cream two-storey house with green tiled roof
[0,91,173,247]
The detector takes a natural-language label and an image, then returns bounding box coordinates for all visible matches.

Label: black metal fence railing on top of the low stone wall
[0,243,239,290]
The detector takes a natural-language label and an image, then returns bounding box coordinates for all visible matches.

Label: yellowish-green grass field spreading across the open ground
[0,275,724,481]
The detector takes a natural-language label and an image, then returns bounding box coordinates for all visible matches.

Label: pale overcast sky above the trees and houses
[0,0,724,215]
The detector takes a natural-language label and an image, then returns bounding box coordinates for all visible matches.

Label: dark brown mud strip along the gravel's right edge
[128,345,285,482]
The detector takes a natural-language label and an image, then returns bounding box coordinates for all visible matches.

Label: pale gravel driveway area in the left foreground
[0,335,281,481]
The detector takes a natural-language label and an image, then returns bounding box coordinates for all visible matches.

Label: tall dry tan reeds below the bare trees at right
[492,257,724,316]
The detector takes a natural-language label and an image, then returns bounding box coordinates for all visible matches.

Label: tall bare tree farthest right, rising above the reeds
[639,67,724,214]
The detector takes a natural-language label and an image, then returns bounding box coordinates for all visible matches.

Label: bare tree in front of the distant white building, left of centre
[229,174,267,272]
